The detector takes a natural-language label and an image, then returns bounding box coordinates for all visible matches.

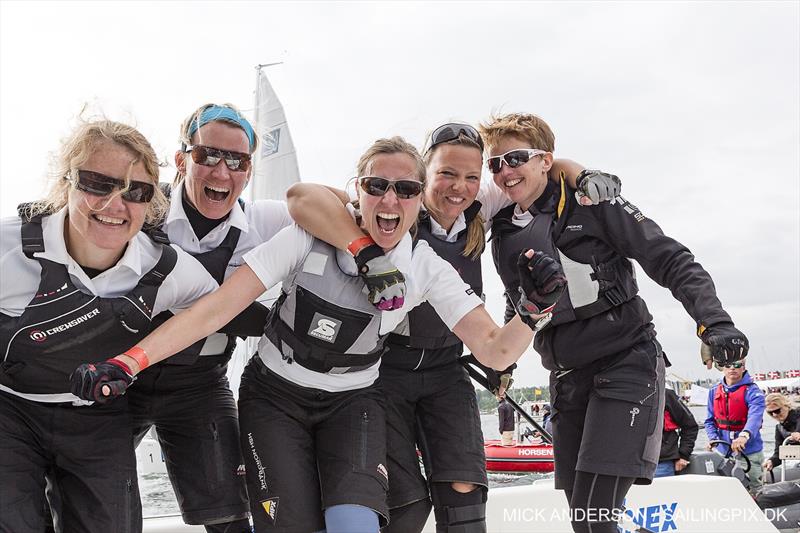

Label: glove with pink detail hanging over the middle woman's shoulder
[354,244,406,311]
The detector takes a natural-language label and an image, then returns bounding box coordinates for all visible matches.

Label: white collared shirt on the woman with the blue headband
[163,181,293,355]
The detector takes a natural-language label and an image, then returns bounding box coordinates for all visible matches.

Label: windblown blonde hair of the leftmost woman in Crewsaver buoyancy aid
[24,119,169,224]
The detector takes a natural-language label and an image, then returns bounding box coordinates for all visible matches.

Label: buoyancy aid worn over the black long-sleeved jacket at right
[492,179,639,326]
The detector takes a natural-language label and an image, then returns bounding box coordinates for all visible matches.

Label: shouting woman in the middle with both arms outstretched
[73,137,564,533]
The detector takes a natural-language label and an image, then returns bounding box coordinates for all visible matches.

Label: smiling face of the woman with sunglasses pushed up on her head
[425,144,483,231]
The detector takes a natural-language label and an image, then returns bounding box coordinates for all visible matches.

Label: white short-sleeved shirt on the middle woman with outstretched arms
[244,225,482,392]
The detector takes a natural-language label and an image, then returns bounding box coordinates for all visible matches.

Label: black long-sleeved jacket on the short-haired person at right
[492,182,732,370]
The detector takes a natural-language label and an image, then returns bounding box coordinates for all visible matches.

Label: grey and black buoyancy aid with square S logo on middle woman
[264,239,385,374]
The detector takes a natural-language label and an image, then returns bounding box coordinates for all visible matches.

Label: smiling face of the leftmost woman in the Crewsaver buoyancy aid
[65,141,154,269]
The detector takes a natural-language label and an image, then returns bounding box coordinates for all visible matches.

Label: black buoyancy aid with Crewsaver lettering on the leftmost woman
[0,211,178,394]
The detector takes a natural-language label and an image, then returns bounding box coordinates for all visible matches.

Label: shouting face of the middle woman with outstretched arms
[357,153,422,251]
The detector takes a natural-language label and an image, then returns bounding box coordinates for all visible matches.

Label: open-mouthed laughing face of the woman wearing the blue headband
[175,121,250,220]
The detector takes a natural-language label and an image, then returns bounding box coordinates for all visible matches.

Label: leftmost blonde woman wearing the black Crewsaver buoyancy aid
[0,120,217,533]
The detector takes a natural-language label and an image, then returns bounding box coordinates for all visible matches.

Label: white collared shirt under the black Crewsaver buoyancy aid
[0,208,217,401]
